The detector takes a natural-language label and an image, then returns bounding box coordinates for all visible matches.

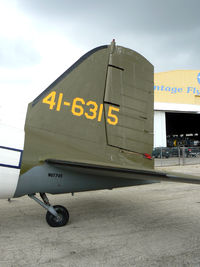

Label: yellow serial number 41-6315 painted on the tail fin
[42,91,119,125]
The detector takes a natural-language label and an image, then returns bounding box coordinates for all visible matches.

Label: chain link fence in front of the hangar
[152,147,200,167]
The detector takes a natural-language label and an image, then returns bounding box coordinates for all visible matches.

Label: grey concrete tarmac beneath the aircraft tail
[0,166,200,267]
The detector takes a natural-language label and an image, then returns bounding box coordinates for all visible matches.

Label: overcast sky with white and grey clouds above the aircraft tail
[0,0,200,134]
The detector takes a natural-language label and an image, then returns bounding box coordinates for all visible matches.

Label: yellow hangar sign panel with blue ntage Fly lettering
[154,70,200,105]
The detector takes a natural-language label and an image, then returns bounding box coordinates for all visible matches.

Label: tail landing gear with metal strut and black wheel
[28,193,69,227]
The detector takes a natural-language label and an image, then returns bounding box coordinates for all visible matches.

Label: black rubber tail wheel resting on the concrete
[46,205,69,227]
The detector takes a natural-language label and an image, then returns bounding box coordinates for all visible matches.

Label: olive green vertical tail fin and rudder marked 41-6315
[21,41,154,174]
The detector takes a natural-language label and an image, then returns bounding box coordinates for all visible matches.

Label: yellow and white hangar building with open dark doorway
[154,70,200,147]
